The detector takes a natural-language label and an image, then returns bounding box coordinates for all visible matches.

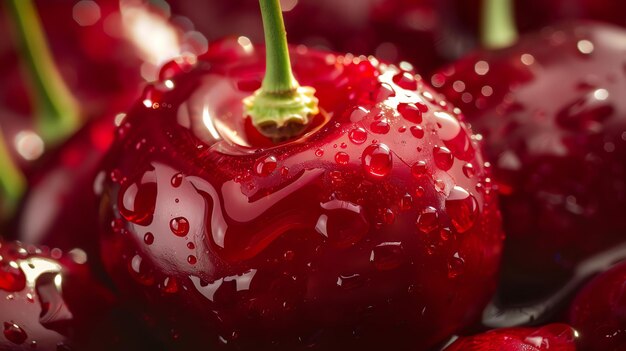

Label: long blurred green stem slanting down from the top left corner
[6,0,80,145]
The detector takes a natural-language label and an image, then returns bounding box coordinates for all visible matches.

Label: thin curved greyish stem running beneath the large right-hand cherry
[483,243,626,328]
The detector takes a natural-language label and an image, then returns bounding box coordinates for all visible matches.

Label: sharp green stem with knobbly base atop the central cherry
[243,0,319,141]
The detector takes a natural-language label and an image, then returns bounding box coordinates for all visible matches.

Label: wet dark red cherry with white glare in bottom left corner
[0,241,159,351]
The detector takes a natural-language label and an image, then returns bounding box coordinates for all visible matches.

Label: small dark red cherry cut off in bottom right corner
[569,263,626,351]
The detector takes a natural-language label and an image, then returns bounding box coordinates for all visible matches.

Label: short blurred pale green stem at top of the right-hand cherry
[481,0,518,49]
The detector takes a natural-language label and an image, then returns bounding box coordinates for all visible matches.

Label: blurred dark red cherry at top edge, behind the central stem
[169,0,471,73]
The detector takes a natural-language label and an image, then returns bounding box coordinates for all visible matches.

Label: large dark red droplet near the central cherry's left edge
[118,171,157,226]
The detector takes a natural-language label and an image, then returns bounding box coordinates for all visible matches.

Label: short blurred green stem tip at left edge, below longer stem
[0,129,26,220]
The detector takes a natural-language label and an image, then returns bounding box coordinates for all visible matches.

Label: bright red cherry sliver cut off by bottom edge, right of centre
[444,324,576,351]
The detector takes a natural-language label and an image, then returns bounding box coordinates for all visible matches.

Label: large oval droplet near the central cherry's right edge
[446,186,479,233]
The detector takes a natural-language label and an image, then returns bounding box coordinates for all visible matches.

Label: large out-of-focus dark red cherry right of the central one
[432,22,626,299]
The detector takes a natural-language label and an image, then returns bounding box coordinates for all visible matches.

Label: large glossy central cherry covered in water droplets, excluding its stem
[96,41,502,350]
